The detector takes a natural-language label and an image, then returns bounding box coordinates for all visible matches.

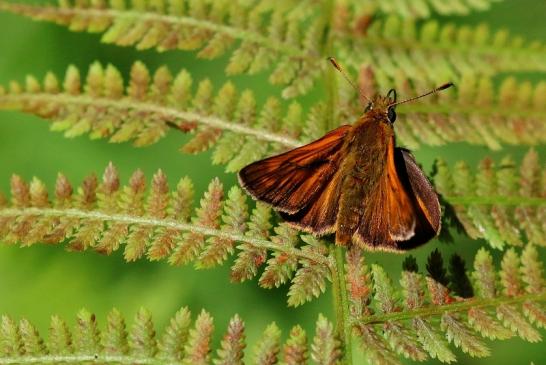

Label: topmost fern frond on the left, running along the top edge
[0,0,326,97]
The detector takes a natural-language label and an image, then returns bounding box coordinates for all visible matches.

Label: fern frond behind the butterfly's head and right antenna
[337,71,546,150]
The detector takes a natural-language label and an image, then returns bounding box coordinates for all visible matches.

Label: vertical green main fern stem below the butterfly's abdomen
[332,245,353,365]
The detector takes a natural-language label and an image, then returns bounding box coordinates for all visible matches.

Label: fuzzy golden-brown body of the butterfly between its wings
[336,108,394,244]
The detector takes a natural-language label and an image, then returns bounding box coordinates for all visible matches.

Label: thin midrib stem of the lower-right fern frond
[356,291,546,325]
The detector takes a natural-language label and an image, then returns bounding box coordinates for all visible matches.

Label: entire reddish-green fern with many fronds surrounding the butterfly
[0,0,546,365]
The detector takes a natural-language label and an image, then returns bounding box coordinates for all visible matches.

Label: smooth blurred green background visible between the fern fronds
[0,0,546,364]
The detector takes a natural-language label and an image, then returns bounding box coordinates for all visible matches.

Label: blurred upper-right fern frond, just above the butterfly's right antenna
[333,10,546,83]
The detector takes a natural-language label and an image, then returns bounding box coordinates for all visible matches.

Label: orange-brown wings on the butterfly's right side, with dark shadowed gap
[354,141,440,251]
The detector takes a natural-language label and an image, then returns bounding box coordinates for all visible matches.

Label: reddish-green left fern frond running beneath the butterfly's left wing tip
[0,164,333,304]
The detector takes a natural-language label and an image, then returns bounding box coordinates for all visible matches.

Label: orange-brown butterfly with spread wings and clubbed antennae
[239,59,453,252]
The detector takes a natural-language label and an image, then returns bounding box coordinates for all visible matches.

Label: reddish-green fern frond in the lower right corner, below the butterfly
[347,245,546,364]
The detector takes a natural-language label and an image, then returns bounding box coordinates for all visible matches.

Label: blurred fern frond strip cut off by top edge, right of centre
[346,0,502,18]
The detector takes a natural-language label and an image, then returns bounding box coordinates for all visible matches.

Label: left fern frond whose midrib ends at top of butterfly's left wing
[0,62,314,171]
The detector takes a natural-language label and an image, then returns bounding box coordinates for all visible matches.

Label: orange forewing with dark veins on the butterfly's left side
[239,125,351,214]
